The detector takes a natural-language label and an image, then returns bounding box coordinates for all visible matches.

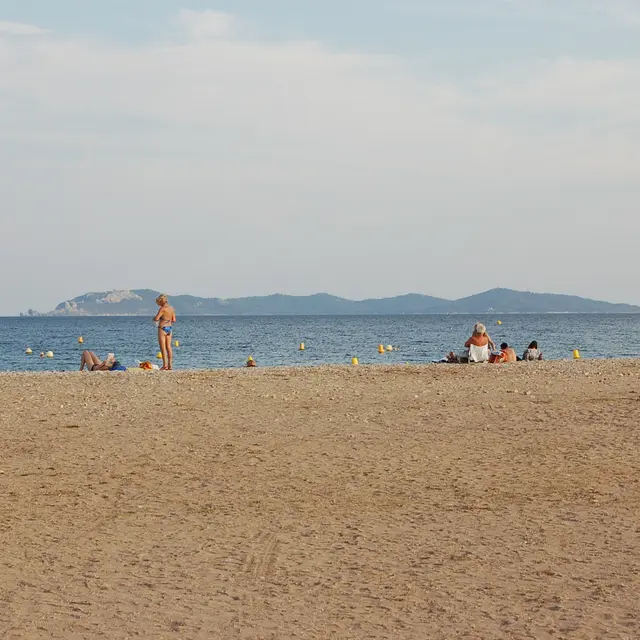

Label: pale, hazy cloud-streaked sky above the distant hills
[0,0,640,315]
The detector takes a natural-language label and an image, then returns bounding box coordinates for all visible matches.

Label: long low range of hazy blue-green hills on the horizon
[35,289,640,316]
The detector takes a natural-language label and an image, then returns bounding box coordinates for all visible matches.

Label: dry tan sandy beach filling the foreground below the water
[0,361,640,639]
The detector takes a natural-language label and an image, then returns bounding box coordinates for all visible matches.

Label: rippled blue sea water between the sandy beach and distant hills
[0,314,640,371]
